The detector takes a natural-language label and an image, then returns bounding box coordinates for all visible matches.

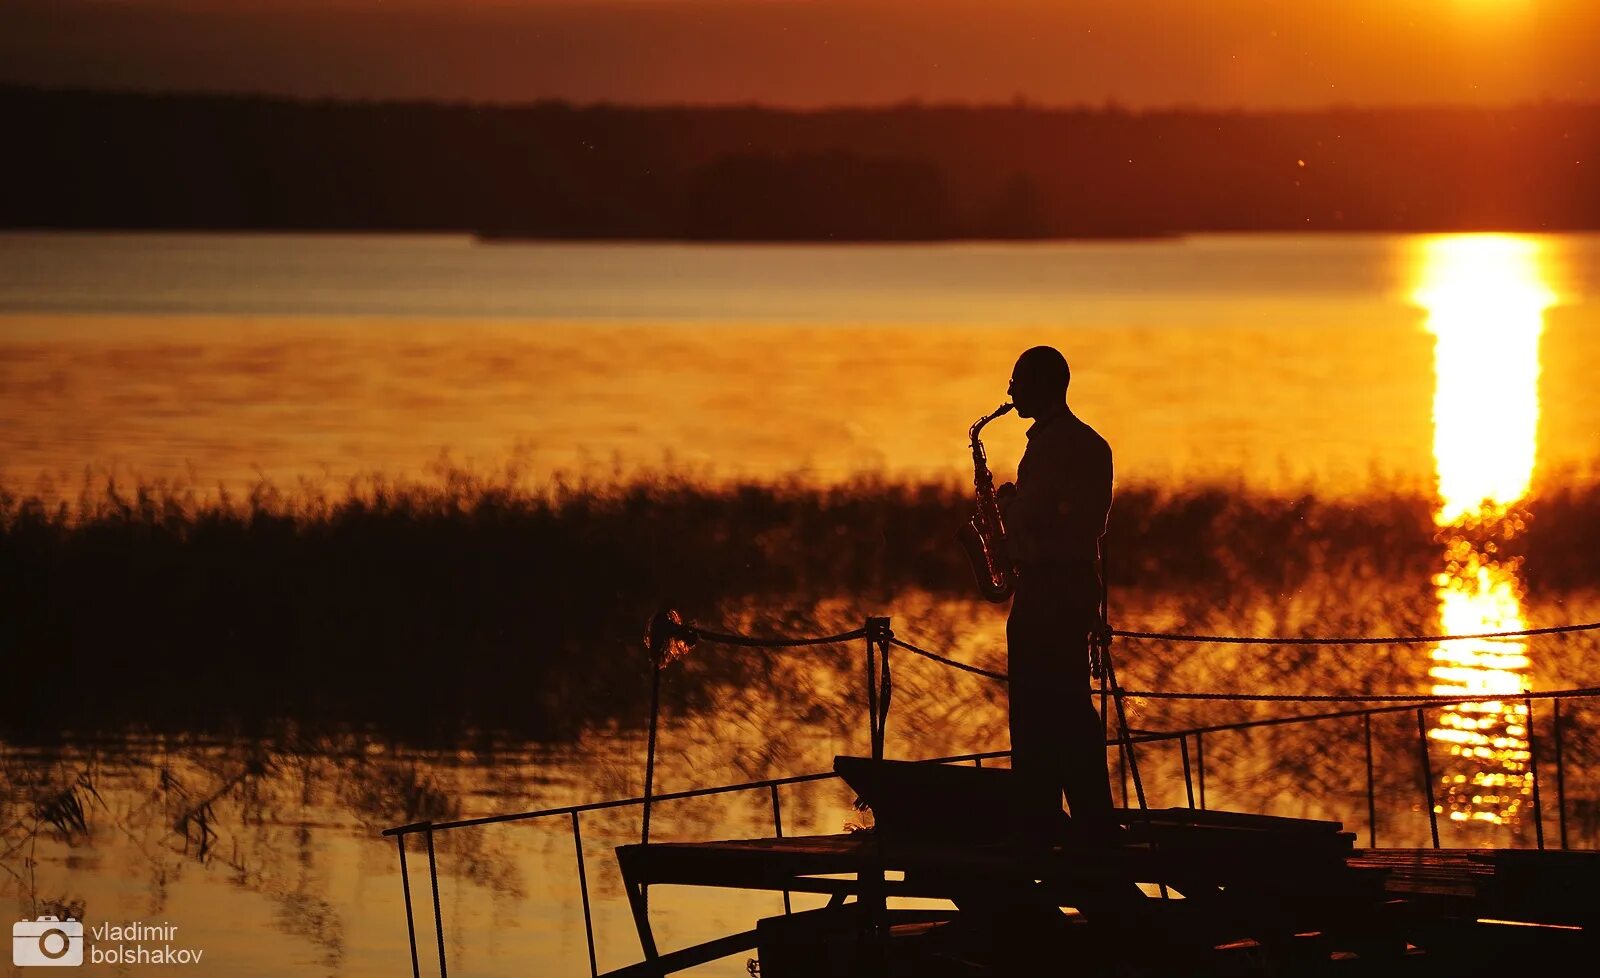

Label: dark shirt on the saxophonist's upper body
[1003,407,1112,567]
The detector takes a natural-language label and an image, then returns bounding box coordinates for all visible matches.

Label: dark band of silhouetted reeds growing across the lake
[0,469,1600,736]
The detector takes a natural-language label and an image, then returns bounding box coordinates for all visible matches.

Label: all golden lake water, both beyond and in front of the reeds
[0,234,1600,978]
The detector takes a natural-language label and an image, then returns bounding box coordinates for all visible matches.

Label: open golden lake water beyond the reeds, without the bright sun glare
[9,235,1600,491]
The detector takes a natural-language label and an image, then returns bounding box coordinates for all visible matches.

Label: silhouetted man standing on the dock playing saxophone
[998,346,1114,842]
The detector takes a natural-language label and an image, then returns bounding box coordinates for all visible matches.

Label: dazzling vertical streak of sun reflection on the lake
[1413,234,1557,824]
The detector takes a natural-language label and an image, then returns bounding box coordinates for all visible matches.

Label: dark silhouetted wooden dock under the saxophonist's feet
[613,759,1600,978]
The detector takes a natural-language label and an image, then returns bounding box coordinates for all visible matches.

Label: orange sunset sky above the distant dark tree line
[0,0,1600,107]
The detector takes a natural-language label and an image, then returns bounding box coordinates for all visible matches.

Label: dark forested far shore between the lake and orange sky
[0,86,1600,240]
